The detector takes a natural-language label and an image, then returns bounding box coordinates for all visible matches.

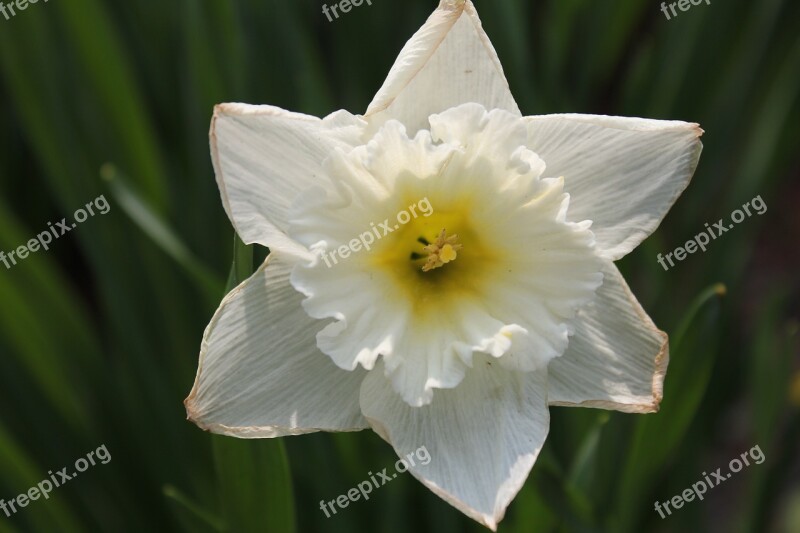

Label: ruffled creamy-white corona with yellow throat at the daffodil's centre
[289,104,602,406]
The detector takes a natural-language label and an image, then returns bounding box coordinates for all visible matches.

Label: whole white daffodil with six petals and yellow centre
[186,0,702,529]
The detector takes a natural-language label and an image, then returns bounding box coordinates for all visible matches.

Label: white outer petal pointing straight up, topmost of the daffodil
[365,0,520,136]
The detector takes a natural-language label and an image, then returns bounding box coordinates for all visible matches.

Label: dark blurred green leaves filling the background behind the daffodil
[0,0,800,533]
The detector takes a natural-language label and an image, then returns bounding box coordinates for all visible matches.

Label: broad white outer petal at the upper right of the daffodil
[526,115,703,261]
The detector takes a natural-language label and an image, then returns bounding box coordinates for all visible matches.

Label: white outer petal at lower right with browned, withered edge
[548,263,669,413]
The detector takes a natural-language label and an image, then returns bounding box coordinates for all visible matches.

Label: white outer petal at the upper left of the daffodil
[210,104,364,256]
